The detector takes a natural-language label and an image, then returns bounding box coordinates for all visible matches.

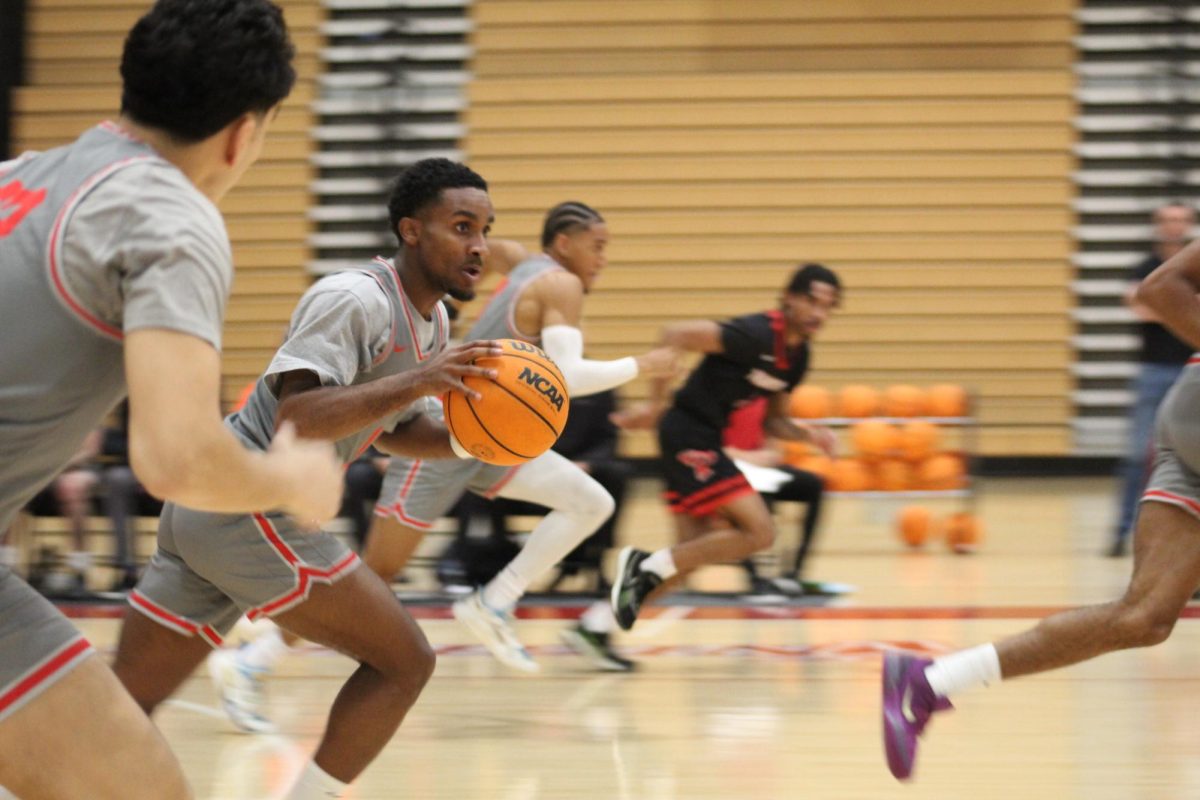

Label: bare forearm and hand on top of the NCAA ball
[277,341,503,439]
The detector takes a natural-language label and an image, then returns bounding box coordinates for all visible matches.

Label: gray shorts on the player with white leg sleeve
[376,456,521,530]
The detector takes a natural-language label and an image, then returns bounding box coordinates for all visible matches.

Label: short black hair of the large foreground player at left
[121,0,296,144]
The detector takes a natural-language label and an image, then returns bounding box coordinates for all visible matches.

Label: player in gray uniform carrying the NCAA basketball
[114,158,500,800]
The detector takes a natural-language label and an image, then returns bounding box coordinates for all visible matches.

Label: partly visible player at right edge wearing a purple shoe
[883,237,1200,780]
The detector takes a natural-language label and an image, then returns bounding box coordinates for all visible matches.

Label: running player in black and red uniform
[612,264,841,631]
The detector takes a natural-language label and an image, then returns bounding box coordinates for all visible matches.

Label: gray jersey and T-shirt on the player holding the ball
[227,258,450,463]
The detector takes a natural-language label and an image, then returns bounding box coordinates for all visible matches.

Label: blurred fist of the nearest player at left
[266,422,344,530]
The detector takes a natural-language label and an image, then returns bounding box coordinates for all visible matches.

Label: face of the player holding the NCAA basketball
[416,187,496,301]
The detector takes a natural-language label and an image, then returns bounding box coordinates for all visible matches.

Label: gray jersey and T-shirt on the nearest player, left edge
[0,122,233,530]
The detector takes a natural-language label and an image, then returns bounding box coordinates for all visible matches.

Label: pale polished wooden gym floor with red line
[68,479,1200,800]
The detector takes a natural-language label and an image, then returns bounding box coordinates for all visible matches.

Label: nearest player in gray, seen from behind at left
[0,0,341,800]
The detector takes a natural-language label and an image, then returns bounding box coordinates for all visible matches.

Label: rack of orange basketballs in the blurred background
[784,384,983,553]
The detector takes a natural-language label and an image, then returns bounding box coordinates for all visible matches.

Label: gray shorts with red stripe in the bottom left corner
[0,566,92,722]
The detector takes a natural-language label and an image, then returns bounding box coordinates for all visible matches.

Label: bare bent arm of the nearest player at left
[125,327,342,523]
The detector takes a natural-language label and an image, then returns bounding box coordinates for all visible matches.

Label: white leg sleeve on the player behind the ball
[484,450,616,609]
